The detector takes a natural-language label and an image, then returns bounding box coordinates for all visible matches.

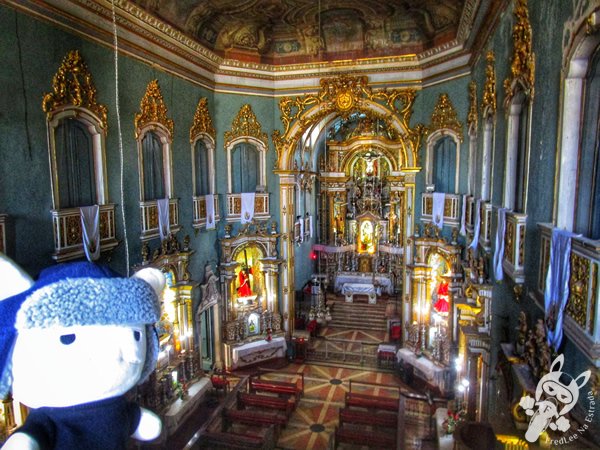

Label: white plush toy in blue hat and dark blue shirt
[0,253,164,450]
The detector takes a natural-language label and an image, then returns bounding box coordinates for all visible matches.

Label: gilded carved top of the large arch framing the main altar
[271,75,425,168]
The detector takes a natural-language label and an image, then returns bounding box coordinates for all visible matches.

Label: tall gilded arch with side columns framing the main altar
[272,76,424,329]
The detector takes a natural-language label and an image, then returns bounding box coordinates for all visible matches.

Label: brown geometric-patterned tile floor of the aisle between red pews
[253,364,426,450]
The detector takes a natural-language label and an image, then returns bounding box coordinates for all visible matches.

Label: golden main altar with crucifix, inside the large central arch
[313,113,414,301]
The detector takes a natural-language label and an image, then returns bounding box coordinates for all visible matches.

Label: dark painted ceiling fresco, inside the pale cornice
[131,0,468,65]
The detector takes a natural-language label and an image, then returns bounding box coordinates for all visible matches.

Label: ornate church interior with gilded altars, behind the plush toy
[0,0,600,450]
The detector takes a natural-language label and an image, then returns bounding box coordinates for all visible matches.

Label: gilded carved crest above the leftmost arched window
[42,50,107,130]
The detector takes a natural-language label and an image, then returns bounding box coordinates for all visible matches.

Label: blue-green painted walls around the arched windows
[0,0,588,422]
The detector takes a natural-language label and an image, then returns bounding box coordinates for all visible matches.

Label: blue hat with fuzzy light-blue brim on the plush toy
[0,262,160,397]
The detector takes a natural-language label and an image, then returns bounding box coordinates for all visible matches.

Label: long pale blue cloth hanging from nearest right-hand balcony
[544,228,578,351]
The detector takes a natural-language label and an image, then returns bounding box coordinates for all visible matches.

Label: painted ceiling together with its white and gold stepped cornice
[2,0,502,95]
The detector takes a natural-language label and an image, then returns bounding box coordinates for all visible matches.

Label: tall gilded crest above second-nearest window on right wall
[504,0,535,104]
